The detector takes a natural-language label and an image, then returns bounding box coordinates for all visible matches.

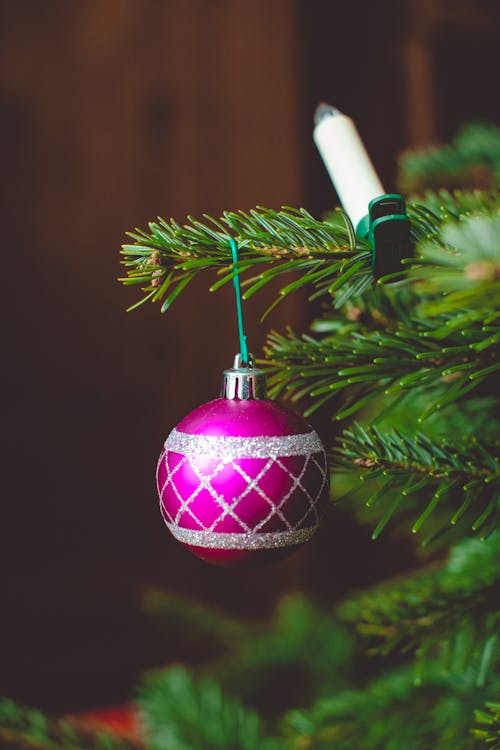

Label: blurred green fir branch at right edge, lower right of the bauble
[339,534,500,686]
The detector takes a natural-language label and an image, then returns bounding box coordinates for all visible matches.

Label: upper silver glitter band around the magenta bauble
[165,428,324,461]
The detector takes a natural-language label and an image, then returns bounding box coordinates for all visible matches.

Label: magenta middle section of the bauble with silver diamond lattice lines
[157,450,327,533]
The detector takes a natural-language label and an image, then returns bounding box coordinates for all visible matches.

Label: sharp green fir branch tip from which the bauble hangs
[120,208,373,312]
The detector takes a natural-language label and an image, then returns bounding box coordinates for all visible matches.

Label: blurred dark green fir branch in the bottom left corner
[0,698,139,750]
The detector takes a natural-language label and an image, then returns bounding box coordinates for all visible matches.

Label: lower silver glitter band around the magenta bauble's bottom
[165,520,318,549]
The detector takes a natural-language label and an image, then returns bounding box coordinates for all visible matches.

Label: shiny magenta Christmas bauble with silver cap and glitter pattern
[157,358,329,565]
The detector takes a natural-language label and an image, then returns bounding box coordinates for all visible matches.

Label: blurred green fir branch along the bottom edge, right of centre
[285,669,492,750]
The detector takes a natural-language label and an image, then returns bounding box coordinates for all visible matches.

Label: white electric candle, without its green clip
[313,104,385,229]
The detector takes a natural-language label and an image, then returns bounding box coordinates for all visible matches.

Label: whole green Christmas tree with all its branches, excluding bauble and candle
[0,125,500,750]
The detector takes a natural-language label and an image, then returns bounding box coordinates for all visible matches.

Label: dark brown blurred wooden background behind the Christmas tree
[0,0,500,711]
